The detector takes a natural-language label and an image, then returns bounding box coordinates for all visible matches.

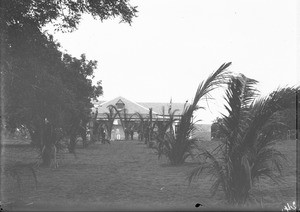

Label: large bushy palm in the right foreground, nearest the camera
[189,75,299,204]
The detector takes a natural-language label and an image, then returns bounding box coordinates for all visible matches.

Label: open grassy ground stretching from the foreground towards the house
[1,141,296,211]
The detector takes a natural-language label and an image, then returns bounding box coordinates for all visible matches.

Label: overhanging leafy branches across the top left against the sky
[0,0,137,30]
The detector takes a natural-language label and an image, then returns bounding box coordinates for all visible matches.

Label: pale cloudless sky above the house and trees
[45,0,300,123]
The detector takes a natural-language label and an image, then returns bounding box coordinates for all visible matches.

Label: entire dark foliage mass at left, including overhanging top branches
[0,0,137,162]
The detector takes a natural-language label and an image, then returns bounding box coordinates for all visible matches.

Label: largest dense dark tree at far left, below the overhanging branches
[1,21,73,149]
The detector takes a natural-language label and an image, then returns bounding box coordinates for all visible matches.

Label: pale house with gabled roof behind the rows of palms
[93,96,210,140]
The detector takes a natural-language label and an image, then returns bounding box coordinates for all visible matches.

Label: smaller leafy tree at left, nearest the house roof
[62,54,102,152]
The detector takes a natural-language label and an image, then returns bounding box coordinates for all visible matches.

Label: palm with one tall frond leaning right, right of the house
[159,63,231,165]
